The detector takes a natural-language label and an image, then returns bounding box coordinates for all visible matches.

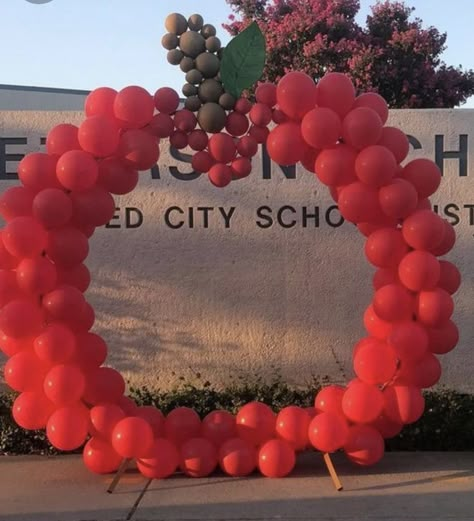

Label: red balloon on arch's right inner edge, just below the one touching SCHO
[365,228,408,268]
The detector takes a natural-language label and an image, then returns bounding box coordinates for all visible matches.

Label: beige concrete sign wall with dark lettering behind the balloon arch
[0,110,474,391]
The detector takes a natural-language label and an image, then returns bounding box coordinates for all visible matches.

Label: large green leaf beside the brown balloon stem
[221,22,265,98]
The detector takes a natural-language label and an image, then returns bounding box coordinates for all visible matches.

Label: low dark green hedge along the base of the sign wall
[0,375,474,454]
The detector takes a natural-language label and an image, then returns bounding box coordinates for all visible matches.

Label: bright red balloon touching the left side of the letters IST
[402,210,445,251]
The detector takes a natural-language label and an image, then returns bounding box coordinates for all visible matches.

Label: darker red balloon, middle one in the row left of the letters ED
[32,188,72,229]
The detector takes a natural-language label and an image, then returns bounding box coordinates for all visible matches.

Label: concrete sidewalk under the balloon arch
[0,453,474,521]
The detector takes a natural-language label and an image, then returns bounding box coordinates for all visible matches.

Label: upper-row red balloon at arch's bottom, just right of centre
[236,402,276,445]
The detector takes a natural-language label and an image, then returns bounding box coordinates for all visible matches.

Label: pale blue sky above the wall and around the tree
[0,0,474,107]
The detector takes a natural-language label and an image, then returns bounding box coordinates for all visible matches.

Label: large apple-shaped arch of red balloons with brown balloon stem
[0,15,460,478]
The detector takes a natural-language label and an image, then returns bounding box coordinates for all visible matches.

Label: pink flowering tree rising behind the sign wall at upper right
[224,0,474,108]
